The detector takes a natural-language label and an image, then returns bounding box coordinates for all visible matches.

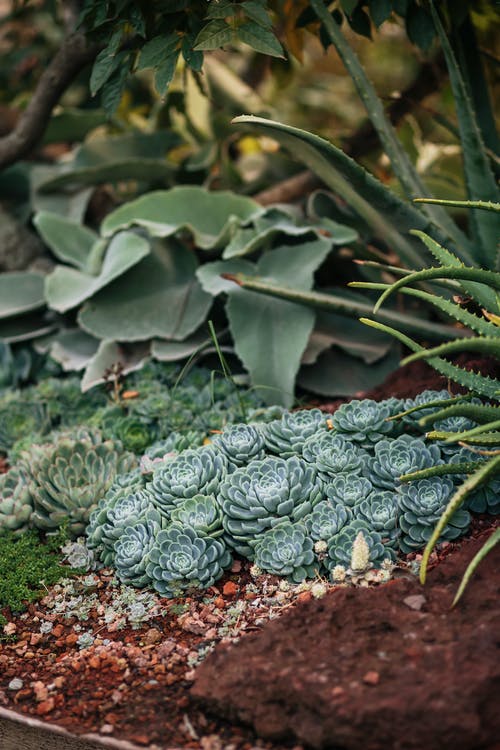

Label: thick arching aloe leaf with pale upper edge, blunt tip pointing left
[233,115,470,266]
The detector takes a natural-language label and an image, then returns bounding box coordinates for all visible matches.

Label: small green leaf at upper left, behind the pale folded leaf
[33,211,99,271]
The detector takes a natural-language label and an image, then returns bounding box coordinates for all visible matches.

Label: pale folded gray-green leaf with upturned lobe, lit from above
[45,232,150,312]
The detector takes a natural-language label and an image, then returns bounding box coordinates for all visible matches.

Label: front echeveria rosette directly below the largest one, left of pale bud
[254,521,319,583]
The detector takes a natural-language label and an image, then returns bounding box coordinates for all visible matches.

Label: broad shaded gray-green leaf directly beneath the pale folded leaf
[78,242,212,341]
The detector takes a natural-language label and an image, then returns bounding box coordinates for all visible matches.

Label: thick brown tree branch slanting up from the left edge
[0,33,101,170]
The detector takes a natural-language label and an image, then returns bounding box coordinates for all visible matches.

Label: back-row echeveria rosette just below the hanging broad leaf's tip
[264,409,328,458]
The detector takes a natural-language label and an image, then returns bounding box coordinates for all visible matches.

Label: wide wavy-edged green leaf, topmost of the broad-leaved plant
[101,186,263,250]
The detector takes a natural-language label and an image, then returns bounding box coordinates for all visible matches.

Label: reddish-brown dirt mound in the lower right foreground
[192,535,500,750]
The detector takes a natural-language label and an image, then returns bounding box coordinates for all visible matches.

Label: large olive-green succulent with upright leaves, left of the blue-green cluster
[20,438,136,537]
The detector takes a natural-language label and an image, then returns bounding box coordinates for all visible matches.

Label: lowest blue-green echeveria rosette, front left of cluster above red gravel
[146,523,232,598]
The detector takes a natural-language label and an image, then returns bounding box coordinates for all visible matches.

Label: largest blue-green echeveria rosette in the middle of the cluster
[217,456,322,559]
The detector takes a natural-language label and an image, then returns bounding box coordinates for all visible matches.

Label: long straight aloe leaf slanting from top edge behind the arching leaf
[311,0,469,256]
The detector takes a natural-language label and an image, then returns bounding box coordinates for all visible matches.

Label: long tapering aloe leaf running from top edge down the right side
[430,2,500,270]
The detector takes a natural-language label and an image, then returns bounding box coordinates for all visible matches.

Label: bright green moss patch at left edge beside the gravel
[0,531,80,625]
